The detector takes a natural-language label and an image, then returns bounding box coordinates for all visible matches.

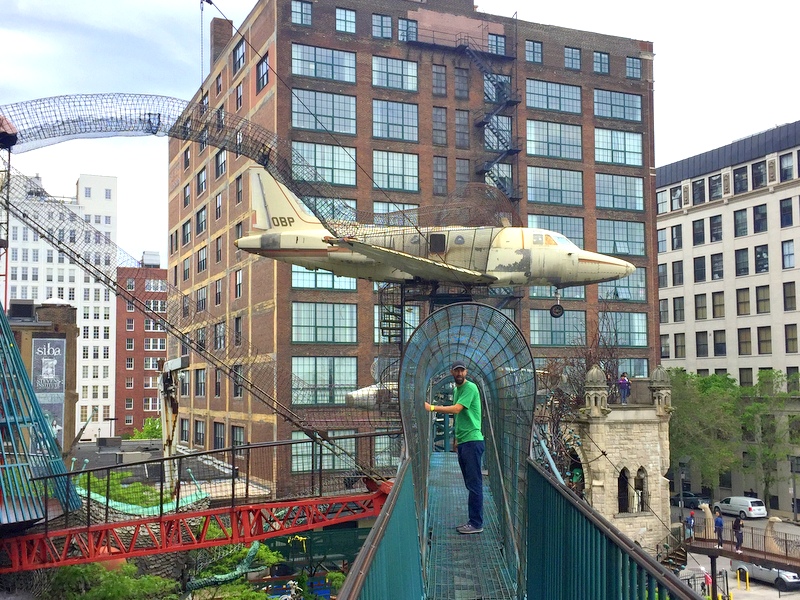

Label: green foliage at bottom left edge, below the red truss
[52,563,180,600]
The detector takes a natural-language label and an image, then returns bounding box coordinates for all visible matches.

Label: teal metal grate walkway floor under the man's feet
[427,452,516,600]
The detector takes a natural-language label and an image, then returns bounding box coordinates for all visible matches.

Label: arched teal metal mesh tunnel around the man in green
[399,303,536,589]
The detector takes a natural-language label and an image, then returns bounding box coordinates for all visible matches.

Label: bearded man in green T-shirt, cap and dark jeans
[425,360,485,534]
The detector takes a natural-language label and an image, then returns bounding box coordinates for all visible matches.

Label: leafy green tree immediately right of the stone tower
[669,369,742,487]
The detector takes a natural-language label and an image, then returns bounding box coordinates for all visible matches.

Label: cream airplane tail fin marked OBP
[250,167,324,231]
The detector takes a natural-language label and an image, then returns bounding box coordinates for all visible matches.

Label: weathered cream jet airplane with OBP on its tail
[234,168,636,318]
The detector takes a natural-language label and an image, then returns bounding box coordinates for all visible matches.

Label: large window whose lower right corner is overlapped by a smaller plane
[292,356,358,404]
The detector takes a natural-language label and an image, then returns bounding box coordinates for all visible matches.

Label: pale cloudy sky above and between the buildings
[0,0,800,266]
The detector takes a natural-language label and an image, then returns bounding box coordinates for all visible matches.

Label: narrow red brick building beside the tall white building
[115,252,167,435]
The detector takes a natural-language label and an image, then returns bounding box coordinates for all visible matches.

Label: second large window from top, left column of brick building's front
[292,89,356,134]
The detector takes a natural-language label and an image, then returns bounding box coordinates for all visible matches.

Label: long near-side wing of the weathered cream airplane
[326,238,497,285]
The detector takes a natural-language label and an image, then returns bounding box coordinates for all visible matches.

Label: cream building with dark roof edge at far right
[656,121,800,389]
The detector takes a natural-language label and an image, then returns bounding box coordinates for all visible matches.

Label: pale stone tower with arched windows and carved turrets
[573,365,672,552]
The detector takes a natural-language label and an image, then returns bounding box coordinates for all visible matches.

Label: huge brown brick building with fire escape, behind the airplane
[168,0,658,488]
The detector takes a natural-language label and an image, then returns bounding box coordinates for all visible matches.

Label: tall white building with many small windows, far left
[5,175,117,439]
